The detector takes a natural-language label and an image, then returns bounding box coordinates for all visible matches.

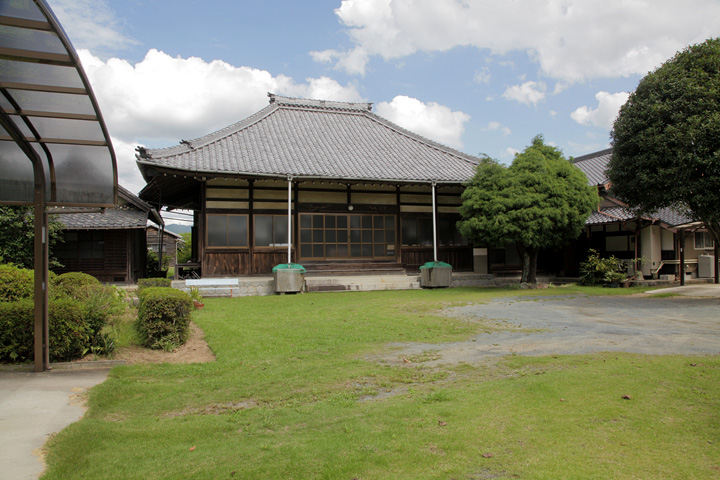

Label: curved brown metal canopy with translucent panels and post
[0,0,117,371]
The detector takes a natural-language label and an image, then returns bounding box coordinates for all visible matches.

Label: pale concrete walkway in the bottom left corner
[0,369,110,480]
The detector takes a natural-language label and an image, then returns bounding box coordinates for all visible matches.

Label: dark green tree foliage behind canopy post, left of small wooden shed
[0,205,63,269]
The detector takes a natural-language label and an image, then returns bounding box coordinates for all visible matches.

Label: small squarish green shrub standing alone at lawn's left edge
[137,287,192,350]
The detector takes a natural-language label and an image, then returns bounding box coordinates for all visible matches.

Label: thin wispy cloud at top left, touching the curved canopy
[48,0,138,55]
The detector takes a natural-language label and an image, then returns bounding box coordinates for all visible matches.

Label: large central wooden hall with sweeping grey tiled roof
[137,94,479,276]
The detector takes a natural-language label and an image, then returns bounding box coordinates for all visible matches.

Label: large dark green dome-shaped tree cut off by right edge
[607,39,720,245]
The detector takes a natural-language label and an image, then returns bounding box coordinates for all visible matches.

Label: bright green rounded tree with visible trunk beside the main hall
[458,136,599,283]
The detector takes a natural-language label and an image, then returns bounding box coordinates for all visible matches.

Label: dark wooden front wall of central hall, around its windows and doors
[201,178,473,276]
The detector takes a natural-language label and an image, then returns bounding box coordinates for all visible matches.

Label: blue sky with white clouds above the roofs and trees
[48,0,720,192]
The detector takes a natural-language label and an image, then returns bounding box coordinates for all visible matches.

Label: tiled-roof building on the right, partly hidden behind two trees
[574,149,712,276]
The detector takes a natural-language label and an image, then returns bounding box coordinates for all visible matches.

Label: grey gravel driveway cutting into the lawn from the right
[386,295,720,366]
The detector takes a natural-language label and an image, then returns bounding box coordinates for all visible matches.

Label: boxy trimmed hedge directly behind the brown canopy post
[0,299,92,363]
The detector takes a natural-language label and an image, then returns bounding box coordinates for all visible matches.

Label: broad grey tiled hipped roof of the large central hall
[137,95,479,183]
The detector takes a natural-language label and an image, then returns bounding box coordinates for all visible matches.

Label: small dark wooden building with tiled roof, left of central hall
[49,186,163,283]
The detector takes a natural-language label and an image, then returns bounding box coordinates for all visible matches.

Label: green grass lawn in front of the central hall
[43,287,720,480]
